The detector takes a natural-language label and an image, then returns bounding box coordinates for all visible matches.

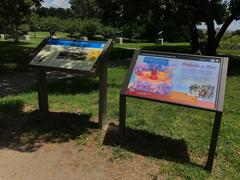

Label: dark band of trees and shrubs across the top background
[0,0,240,55]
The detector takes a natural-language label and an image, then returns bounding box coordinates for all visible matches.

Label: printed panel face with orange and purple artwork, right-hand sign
[125,54,224,110]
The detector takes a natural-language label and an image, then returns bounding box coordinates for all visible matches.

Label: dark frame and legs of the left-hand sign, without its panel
[28,38,113,129]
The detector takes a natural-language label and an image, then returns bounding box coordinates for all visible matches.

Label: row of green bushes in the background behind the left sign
[19,17,119,39]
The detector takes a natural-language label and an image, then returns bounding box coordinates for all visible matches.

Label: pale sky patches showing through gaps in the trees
[42,0,240,31]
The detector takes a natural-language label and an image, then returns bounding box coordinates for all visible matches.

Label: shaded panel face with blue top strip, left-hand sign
[30,39,106,71]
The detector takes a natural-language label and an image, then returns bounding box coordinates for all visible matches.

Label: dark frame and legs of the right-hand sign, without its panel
[119,50,228,171]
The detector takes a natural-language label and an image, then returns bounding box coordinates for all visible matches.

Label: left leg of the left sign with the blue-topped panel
[37,70,48,117]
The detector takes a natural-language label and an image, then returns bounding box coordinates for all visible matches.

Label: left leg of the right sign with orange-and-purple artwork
[119,95,126,145]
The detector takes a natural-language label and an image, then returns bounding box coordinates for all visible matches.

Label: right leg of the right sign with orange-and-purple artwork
[205,112,222,171]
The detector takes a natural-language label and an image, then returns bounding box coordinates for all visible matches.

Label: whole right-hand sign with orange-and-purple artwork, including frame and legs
[119,51,228,171]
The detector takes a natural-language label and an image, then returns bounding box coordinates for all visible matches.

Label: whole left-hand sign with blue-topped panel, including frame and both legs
[29,39,112,128]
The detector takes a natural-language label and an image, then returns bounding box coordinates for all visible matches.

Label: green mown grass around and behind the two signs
[0,34,240,179]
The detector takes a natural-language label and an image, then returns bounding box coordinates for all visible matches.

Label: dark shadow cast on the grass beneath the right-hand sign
[103,124,193,166]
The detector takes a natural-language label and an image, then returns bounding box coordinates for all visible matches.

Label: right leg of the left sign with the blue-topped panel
[98,58,107,129]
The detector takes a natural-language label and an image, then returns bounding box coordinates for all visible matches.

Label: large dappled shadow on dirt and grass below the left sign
[0,100,98,152]
